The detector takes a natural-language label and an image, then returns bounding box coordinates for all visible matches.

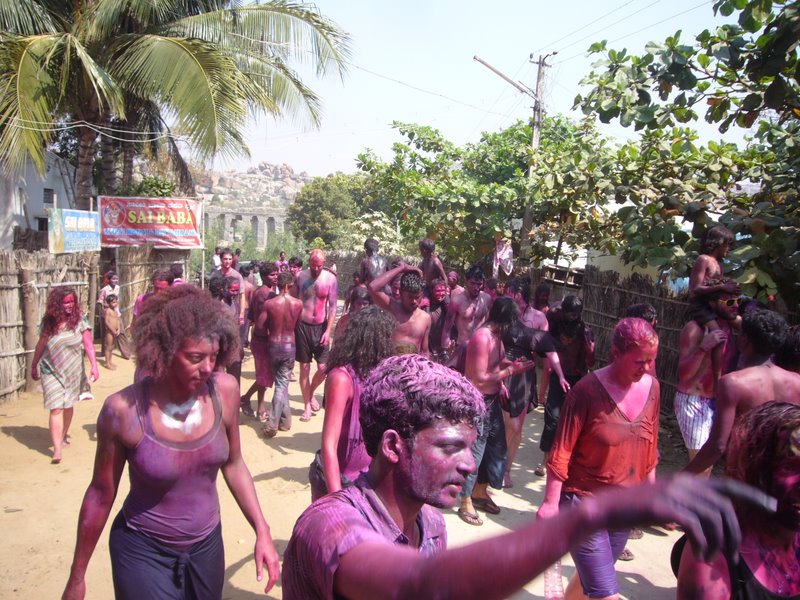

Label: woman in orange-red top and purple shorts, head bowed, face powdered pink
[539,318,659,600]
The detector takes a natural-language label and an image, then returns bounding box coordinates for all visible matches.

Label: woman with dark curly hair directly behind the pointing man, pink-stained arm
[309,306,395,502]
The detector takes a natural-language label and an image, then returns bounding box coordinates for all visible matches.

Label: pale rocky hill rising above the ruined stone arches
[194,162,313,209]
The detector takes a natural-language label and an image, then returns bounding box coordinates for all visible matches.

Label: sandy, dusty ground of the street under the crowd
[0,350,683,600]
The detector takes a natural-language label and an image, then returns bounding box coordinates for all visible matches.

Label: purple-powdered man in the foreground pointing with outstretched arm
[282,354,768,600]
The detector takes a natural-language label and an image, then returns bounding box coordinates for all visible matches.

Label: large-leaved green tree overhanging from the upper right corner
[576,0,800,304]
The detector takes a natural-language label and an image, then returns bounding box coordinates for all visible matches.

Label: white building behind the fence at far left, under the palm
[0,152,75,248]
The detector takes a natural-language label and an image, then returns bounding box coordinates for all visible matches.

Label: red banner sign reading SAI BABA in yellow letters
[99,196,203,248]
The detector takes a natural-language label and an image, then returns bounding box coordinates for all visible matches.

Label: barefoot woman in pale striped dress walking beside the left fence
[31,286,100,464]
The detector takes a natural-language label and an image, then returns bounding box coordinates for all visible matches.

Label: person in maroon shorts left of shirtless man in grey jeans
[240,262,278,422]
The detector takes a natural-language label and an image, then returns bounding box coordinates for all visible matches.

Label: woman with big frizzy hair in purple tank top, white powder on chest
[63,285,278,599]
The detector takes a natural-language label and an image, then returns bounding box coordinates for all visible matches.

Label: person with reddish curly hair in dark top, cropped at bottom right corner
[672,402,800,600]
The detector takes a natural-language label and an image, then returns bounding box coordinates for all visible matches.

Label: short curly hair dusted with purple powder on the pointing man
[359,354,486,457]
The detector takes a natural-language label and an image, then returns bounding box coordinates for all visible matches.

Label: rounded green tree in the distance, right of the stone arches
[286,173,364,247]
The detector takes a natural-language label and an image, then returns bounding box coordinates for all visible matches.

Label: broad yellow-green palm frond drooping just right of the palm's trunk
[111,35,248,157]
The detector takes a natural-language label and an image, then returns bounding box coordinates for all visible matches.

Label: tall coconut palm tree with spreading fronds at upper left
[0,0,349,208]
